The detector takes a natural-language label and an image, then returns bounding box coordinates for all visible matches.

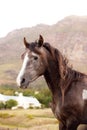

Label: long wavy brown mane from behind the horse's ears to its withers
[43,43,84,90]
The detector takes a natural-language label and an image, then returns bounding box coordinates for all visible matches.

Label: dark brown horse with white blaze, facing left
[17,35,87,130]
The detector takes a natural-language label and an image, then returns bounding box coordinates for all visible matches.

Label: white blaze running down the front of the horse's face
[17,53,29,86]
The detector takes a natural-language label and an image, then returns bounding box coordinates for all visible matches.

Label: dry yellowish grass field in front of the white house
[0,109,58,130]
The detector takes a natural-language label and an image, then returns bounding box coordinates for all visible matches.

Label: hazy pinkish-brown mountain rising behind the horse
[0,16,87,85]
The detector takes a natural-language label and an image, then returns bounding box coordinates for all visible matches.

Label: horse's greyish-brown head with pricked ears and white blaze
[17,35,47,88]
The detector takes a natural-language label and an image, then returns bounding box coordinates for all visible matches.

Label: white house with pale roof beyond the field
[0,93,41,109]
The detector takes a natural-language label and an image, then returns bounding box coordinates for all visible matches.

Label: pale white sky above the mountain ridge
[0,0,87,37]
